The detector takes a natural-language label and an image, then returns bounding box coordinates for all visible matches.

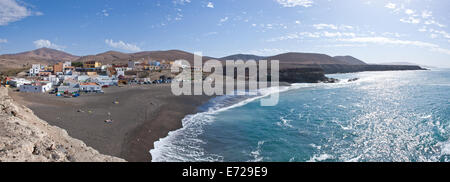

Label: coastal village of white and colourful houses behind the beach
[1,60,186,97]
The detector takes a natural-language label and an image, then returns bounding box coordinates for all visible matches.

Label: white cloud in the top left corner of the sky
[0,0,42,26]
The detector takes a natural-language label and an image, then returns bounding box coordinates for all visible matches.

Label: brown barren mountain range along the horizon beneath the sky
[0,48,422,72]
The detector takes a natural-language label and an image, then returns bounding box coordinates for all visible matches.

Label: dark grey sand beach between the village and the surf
[10,85,211,162]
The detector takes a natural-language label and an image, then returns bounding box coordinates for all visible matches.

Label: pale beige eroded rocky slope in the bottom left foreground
[0,87,125,162]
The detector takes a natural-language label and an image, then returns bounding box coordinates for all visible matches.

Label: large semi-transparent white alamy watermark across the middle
[171,52,279,106]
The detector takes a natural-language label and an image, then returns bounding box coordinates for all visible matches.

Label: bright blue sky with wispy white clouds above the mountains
[0,0,450,67]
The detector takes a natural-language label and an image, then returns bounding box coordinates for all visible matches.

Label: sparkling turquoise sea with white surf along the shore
[150,69,450,162]
